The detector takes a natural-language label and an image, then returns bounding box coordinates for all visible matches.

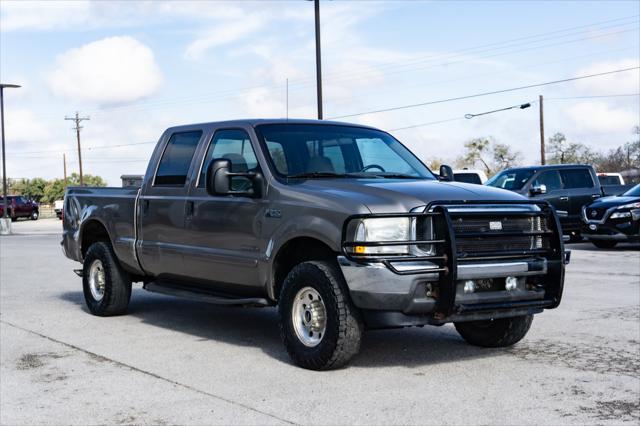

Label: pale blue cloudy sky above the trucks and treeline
[0,0,640,185]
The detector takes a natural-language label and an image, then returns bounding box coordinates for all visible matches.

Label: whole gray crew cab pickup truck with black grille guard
[62,120,568,370]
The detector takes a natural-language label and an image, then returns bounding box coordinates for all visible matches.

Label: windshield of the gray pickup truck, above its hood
[256,124,435,179]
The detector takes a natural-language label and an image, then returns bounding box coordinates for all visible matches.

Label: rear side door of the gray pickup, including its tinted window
[137,129,203,279]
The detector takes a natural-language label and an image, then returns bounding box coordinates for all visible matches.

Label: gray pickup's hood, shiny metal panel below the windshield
[298,179,527,213]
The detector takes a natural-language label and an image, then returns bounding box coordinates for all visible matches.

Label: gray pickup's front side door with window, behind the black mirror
[185,129,266,294]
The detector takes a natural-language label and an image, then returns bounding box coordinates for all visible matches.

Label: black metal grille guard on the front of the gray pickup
[342,200,568,319]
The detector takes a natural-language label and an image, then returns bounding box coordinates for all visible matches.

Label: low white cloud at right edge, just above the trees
[565,102,638,133]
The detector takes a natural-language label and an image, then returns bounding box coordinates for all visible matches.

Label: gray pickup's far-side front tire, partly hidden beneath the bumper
[455,315,533,348]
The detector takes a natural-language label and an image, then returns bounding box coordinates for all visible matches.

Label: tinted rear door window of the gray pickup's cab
[153,130,202,186]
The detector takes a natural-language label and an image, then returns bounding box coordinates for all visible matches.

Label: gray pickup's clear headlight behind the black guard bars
[347,217,412,255]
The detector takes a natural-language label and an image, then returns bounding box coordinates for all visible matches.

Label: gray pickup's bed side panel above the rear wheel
[63,186,141,273]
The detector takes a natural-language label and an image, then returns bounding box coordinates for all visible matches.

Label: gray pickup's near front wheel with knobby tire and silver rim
[278,261,363,370]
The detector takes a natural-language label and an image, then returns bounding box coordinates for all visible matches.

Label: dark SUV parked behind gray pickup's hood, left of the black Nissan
[485,164,602,239]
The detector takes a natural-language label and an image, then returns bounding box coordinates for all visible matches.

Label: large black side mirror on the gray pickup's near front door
[206,158,262,198]
